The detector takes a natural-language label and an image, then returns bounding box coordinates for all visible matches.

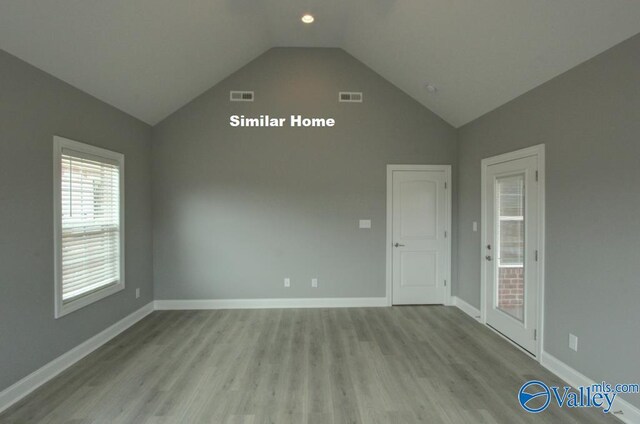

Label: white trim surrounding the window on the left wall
[53,136,125,318]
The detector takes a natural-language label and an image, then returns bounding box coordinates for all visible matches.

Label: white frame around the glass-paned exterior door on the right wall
[480,144,545,362]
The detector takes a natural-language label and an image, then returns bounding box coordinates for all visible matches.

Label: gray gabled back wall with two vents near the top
[153,48,457,299]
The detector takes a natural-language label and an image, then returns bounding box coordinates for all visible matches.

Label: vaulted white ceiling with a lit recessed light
[0,0,640,127]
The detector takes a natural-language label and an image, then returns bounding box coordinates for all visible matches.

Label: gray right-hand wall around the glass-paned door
[458,36,640,406]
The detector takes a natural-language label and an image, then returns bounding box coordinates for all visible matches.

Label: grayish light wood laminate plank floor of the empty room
[0,306,619,424]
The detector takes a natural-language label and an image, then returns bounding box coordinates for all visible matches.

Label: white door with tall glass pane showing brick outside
[483,155,540,355]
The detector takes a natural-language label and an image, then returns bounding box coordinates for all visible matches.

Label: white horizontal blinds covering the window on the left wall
[61,149,120,302]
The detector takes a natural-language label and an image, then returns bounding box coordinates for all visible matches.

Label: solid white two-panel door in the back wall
[391,167,450,305]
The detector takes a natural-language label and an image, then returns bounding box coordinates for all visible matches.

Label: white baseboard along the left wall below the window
[0,302,154,412]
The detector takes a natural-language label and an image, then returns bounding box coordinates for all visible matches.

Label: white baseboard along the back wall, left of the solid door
[155,297,388,310]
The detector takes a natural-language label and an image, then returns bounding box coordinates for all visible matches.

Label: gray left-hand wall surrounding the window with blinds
[0,50,153,391]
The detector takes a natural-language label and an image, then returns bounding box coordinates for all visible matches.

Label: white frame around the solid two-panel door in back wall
[387,165,451,306]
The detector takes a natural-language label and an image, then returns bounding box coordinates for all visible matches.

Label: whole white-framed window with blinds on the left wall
[55,137,124,316]
